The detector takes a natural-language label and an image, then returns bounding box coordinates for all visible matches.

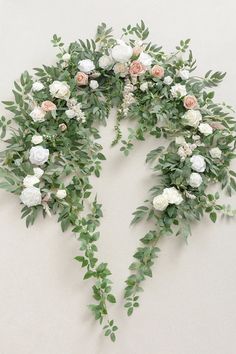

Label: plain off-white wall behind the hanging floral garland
[0,0,236,354]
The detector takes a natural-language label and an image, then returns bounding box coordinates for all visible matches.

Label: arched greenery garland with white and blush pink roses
[0,21,236,341]
